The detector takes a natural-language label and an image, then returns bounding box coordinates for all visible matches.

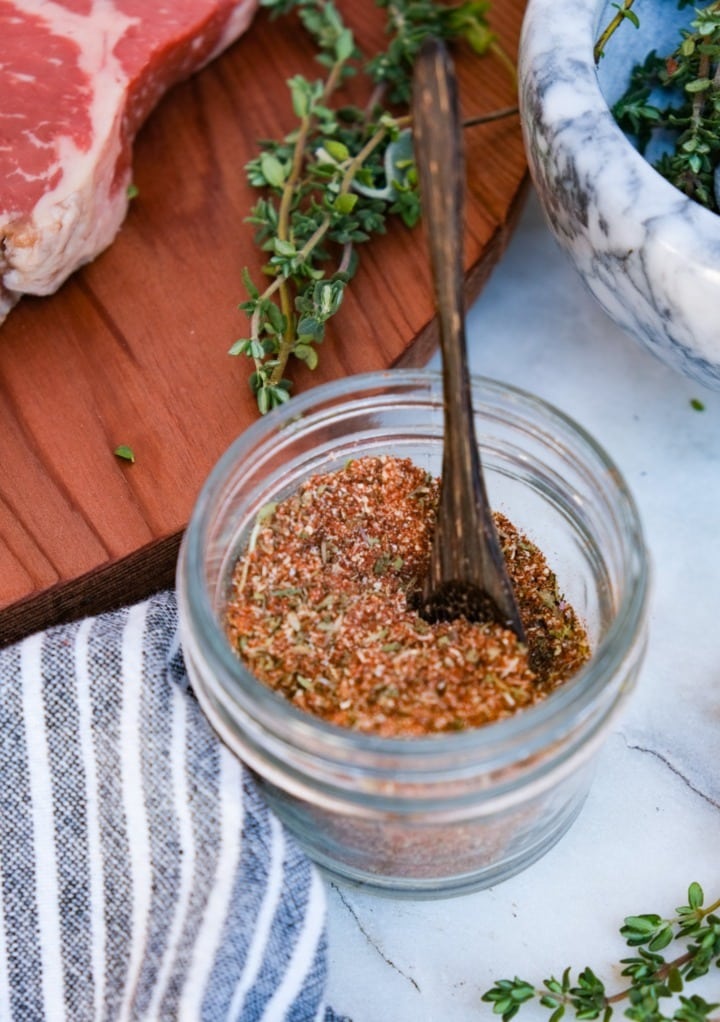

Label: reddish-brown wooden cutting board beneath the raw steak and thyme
[0,0,526,645]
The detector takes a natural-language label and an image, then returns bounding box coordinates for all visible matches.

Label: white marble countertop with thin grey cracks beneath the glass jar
[328,195,720,1022]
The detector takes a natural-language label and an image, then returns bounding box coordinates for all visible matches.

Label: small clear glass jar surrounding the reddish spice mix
[178,370,647,897]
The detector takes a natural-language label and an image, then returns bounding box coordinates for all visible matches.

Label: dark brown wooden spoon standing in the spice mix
[413,38,524,641]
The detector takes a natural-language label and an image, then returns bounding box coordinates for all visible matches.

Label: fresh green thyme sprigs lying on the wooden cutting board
[230,0,517,413]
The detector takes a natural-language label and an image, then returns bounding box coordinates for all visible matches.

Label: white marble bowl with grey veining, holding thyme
[520,0,720,388]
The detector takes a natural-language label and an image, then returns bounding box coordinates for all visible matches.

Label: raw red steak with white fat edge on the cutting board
[0,0,258,322]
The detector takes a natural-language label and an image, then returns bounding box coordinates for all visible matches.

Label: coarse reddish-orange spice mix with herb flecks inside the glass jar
[227,456,589,736]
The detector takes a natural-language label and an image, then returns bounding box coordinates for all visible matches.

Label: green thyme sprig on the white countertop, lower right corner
[482,883,720,1022]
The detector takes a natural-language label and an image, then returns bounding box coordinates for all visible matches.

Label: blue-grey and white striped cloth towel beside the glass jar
[0,593,347,1022]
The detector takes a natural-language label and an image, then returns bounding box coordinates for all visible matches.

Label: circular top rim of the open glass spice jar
[178,369,650,760]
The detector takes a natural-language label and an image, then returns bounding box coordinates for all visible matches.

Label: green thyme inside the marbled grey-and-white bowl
[613,0,720,213]
